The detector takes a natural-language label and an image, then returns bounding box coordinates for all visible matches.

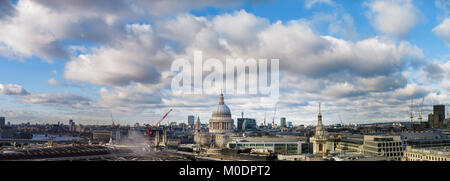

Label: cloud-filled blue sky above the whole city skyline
[0,0,450,124]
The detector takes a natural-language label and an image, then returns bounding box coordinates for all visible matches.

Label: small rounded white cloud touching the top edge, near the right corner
[365,0,418,38]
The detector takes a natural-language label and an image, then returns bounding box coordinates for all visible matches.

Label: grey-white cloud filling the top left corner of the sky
[0,0,131,62]
